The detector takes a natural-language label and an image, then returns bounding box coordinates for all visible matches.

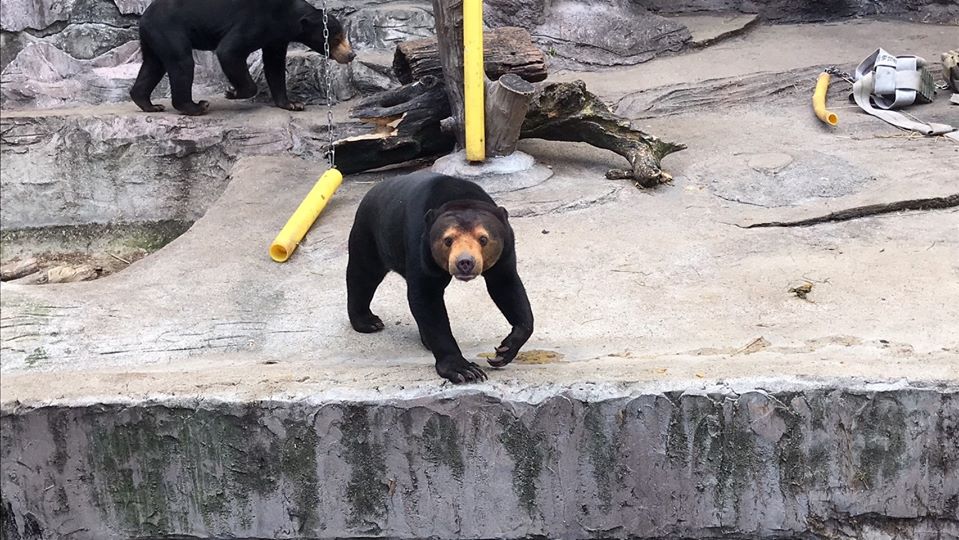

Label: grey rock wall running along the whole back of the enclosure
[0,0,959,109]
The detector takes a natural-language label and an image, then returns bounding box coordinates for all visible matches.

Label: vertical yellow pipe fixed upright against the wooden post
[463,0,486,161]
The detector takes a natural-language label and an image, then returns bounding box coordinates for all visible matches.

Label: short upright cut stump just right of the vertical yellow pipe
[486,73,536,157]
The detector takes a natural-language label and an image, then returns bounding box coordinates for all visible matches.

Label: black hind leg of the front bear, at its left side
[346,232,389,334]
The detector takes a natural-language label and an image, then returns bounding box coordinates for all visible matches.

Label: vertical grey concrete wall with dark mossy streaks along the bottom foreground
[0,381,959,539]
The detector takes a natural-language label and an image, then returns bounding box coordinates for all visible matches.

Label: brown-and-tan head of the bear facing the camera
[426,201,512,281]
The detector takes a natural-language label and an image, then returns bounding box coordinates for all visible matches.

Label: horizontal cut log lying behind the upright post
[393,26,546,84]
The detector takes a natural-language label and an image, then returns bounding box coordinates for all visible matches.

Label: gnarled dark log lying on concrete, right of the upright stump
[520,81,686,187]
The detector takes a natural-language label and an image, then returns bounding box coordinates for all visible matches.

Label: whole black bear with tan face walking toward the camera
[346,172,533,383]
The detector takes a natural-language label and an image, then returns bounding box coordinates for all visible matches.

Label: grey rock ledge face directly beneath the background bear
[0,108,368,229]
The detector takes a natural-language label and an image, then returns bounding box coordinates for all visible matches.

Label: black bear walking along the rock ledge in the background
[130,0,356,115]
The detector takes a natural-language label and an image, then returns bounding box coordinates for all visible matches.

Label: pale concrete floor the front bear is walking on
[0,37,959,403]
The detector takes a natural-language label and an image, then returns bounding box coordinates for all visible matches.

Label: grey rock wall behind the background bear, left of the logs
[0,0,420,110]
